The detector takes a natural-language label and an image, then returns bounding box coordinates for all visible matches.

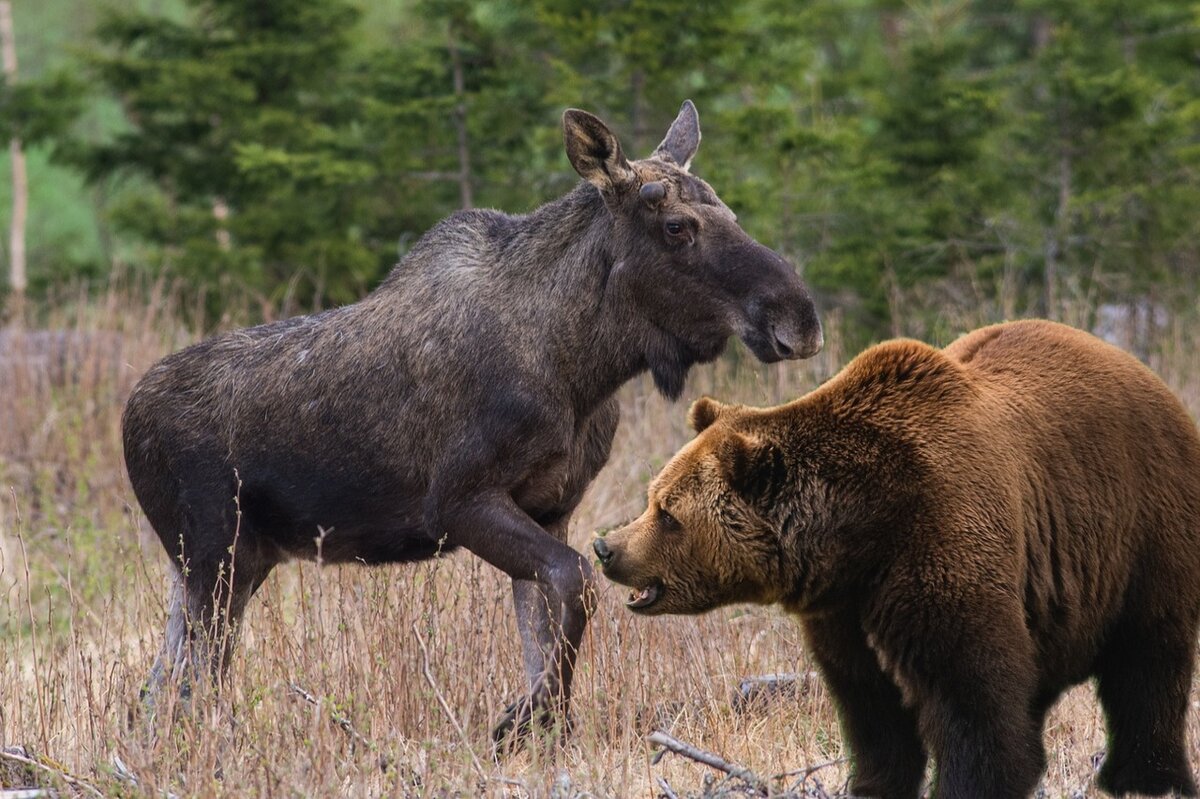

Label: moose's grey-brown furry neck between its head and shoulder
[505,184,692,415]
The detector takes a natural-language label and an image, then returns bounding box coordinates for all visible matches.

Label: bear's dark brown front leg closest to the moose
[804,617,928,799]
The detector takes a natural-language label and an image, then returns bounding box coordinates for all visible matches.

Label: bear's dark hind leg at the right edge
[1096,620,1196,797]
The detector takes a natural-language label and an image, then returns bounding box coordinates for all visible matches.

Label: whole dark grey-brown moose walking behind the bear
[122,101,822,745]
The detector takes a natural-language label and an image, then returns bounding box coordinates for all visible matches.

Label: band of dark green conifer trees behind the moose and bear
[9,0,1200,337]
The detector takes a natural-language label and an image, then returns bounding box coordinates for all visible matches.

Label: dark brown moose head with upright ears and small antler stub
[563,100,823,397]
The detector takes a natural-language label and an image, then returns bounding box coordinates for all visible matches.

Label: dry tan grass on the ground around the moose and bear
[0,283,1200,797]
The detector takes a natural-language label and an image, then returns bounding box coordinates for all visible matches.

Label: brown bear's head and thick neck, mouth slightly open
[593,385,924,614]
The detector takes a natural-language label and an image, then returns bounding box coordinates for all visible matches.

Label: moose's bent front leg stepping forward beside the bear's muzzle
[436,494,595,747]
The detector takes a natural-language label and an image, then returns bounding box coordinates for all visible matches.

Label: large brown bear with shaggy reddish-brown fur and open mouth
[594,322,1200,799]
